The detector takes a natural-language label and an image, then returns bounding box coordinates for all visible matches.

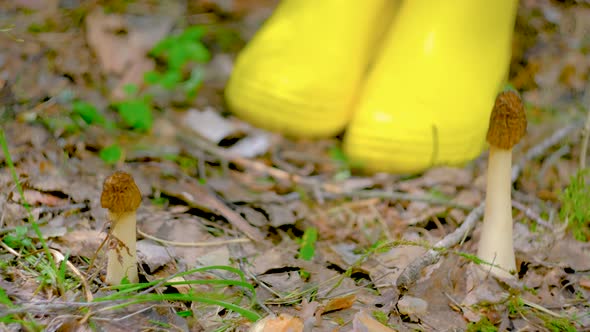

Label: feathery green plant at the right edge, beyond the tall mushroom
[559,169,590,242]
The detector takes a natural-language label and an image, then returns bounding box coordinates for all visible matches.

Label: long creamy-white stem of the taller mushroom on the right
[477,145,516,278]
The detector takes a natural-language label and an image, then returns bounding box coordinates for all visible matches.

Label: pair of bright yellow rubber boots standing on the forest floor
[225,0,518,173]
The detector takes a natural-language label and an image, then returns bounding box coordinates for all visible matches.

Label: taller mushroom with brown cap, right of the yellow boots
[477,91,527,278]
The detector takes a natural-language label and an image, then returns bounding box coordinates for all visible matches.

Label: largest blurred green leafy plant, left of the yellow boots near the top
[144,26,211,98]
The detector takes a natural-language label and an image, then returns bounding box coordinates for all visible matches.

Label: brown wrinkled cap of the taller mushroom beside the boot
[487,90,527,150]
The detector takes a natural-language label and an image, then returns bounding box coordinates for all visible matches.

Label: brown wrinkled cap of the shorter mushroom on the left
[100,171,141,213]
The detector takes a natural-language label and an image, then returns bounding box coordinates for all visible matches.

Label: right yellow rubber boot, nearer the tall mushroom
[344,0,518,173]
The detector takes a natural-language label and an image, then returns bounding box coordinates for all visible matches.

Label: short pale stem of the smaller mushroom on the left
[106,211,139,285]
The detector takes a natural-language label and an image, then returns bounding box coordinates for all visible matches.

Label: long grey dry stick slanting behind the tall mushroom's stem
[396,124,579,290]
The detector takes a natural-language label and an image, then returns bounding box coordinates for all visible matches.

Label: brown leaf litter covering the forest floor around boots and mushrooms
[0,0,590,332]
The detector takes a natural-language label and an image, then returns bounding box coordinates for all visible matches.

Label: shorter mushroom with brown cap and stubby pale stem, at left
[100,172,141,285]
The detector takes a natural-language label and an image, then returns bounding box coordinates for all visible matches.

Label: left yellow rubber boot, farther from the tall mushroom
[225,0,399,137]
